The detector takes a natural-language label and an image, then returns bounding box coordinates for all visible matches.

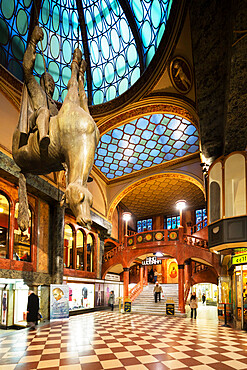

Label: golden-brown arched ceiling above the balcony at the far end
[121,174,205,219]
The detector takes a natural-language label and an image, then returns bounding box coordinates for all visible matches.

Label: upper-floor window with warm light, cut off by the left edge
[0,194,9,258]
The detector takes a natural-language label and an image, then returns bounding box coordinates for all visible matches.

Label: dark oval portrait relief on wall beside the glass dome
[169,56,193,94]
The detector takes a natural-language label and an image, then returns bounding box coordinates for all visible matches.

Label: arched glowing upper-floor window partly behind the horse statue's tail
[13,203,32,262]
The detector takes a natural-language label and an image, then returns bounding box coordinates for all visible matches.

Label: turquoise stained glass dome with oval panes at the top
[0,0,172,104]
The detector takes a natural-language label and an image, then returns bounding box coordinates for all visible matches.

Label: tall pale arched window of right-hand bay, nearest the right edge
[225,154,246,217]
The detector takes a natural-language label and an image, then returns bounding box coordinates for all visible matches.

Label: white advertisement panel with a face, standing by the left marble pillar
[50,284,69,320]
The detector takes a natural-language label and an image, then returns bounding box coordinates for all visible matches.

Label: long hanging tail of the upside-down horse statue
[17,172,29,231]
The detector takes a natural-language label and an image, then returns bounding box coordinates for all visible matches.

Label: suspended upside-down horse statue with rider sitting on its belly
[12,26,99,231]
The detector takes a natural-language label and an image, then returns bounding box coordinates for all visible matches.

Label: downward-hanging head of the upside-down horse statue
[61,182,93,229]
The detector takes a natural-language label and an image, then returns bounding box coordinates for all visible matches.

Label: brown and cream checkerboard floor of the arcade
[0,311,247,370]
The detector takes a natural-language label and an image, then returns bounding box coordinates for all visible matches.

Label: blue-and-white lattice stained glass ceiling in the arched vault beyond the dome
[95,114,199,179]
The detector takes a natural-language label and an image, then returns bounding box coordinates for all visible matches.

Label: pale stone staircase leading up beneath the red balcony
[131,284,180,316]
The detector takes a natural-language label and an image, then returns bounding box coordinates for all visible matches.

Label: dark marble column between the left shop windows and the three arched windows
[50,202,65,284]
